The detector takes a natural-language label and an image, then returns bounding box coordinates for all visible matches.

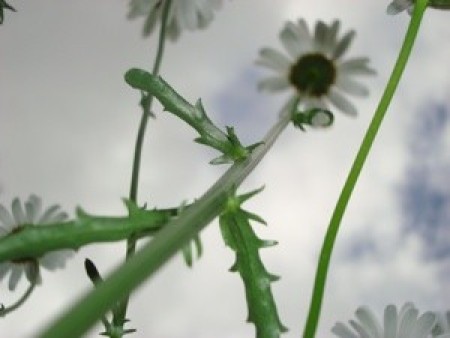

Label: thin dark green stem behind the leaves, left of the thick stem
[113,0,172,326]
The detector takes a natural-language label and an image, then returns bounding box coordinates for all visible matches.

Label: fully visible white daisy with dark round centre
[257,19,375,116]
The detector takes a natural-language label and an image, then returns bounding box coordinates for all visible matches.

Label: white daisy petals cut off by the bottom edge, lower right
[331,303,450,338]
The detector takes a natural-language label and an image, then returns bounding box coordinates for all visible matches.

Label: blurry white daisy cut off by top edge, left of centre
[128,0,222,40]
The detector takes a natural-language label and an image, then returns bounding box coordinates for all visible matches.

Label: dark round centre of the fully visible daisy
[289,53,336,97]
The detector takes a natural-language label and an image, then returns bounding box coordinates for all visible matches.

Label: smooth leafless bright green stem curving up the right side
[303,0,427,338]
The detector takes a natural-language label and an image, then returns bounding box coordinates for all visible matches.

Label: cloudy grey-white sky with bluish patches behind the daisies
[0,0,450,338]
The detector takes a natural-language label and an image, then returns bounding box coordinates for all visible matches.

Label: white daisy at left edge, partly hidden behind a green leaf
[0,195,73,291]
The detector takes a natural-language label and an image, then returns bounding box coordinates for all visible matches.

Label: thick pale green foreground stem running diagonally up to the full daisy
[39,97,298,338]
